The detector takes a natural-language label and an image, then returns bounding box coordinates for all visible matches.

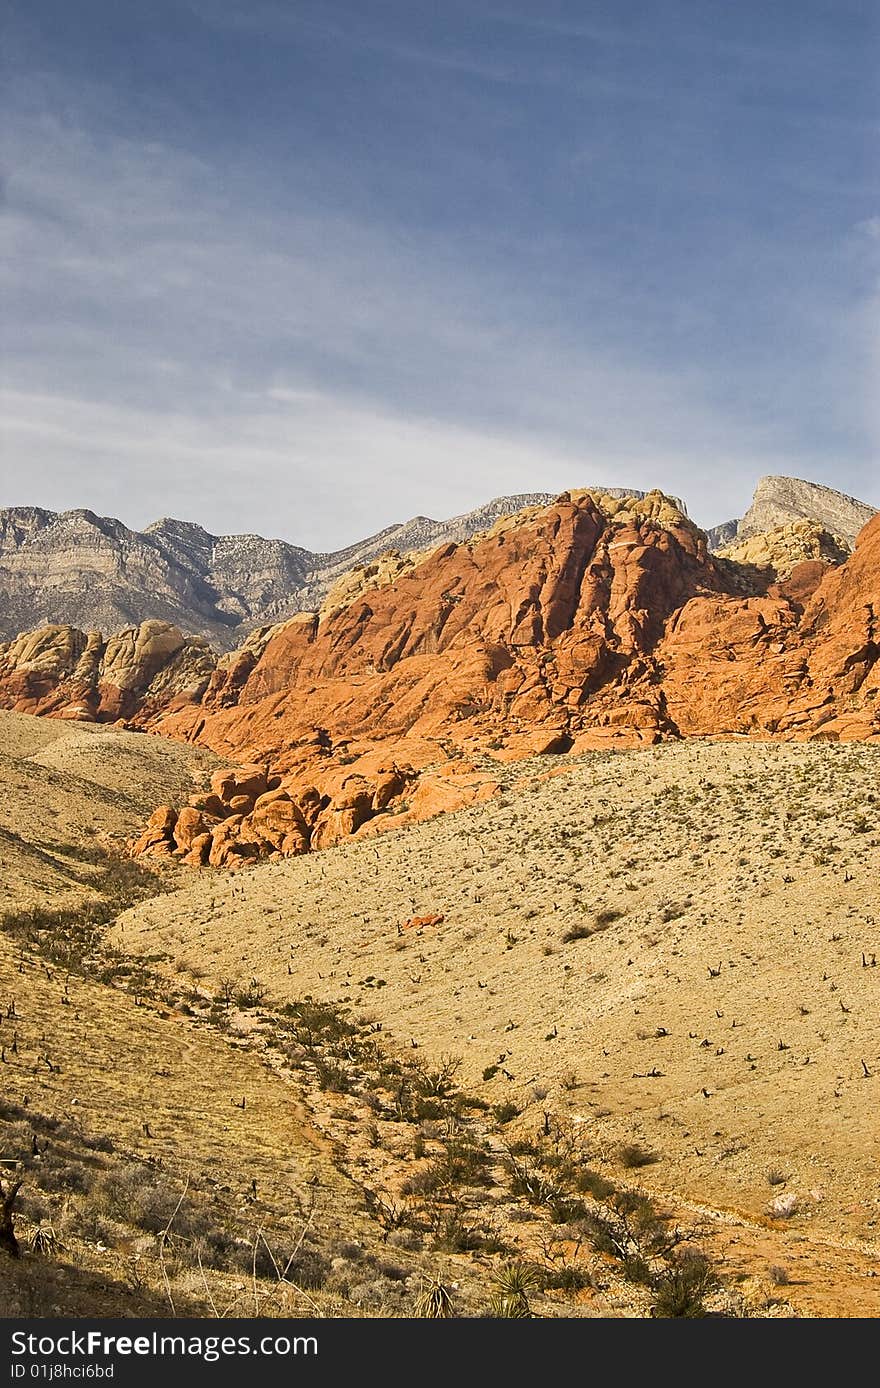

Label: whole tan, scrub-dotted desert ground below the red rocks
[0,715,880,1316]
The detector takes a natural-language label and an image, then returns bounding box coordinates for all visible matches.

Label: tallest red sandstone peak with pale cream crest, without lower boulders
[150,493,734,770]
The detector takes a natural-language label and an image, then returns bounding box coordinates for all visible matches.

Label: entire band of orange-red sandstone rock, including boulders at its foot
[0,493,880,866]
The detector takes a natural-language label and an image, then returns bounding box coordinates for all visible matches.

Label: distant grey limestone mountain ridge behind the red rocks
[0,477,874,650]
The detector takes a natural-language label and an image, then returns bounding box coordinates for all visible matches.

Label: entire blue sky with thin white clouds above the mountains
[0,0,880,548]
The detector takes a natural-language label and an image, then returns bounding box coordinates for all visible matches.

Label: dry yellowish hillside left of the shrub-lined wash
[0,712,535,1317]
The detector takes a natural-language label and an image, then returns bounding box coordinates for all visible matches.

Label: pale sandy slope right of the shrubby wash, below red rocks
[117,741,880,1271]
